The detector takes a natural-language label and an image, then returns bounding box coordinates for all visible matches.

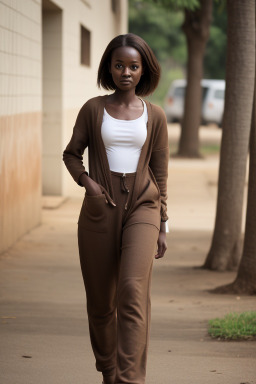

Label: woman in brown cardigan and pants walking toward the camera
[63,34,169,384]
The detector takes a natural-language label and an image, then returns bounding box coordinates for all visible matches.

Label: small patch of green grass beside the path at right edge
[208,311,256,340]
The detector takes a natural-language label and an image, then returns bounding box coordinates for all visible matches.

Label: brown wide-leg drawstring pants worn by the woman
[78,172,160,384]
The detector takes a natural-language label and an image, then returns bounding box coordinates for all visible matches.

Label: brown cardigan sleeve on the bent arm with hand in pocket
[63,103,89,186]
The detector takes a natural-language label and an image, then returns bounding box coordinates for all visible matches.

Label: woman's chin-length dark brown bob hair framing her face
[97,33,161,96]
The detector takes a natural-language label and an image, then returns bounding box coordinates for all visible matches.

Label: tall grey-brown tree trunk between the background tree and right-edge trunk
[203,0,255,271]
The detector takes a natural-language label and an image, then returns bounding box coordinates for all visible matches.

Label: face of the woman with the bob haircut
[110,47,143,91]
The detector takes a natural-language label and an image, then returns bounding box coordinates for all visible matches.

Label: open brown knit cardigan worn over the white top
[63,95,169,221]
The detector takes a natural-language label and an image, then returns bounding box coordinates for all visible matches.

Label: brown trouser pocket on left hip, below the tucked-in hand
[78,193,108,232]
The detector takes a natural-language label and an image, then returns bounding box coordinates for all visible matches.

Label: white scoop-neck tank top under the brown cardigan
[101,100,148,173]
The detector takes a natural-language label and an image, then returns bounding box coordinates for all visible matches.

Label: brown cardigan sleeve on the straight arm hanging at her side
[149,106,169,221]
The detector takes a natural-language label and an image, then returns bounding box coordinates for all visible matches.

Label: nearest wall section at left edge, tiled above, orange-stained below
[0,0,42,252]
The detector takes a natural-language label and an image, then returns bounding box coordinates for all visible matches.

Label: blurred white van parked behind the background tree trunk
[164,79,225,126]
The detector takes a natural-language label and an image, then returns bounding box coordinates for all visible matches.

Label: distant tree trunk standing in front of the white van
[177,0,212,157]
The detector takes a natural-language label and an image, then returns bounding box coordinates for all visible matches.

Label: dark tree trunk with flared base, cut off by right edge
[214,75,256,295]
